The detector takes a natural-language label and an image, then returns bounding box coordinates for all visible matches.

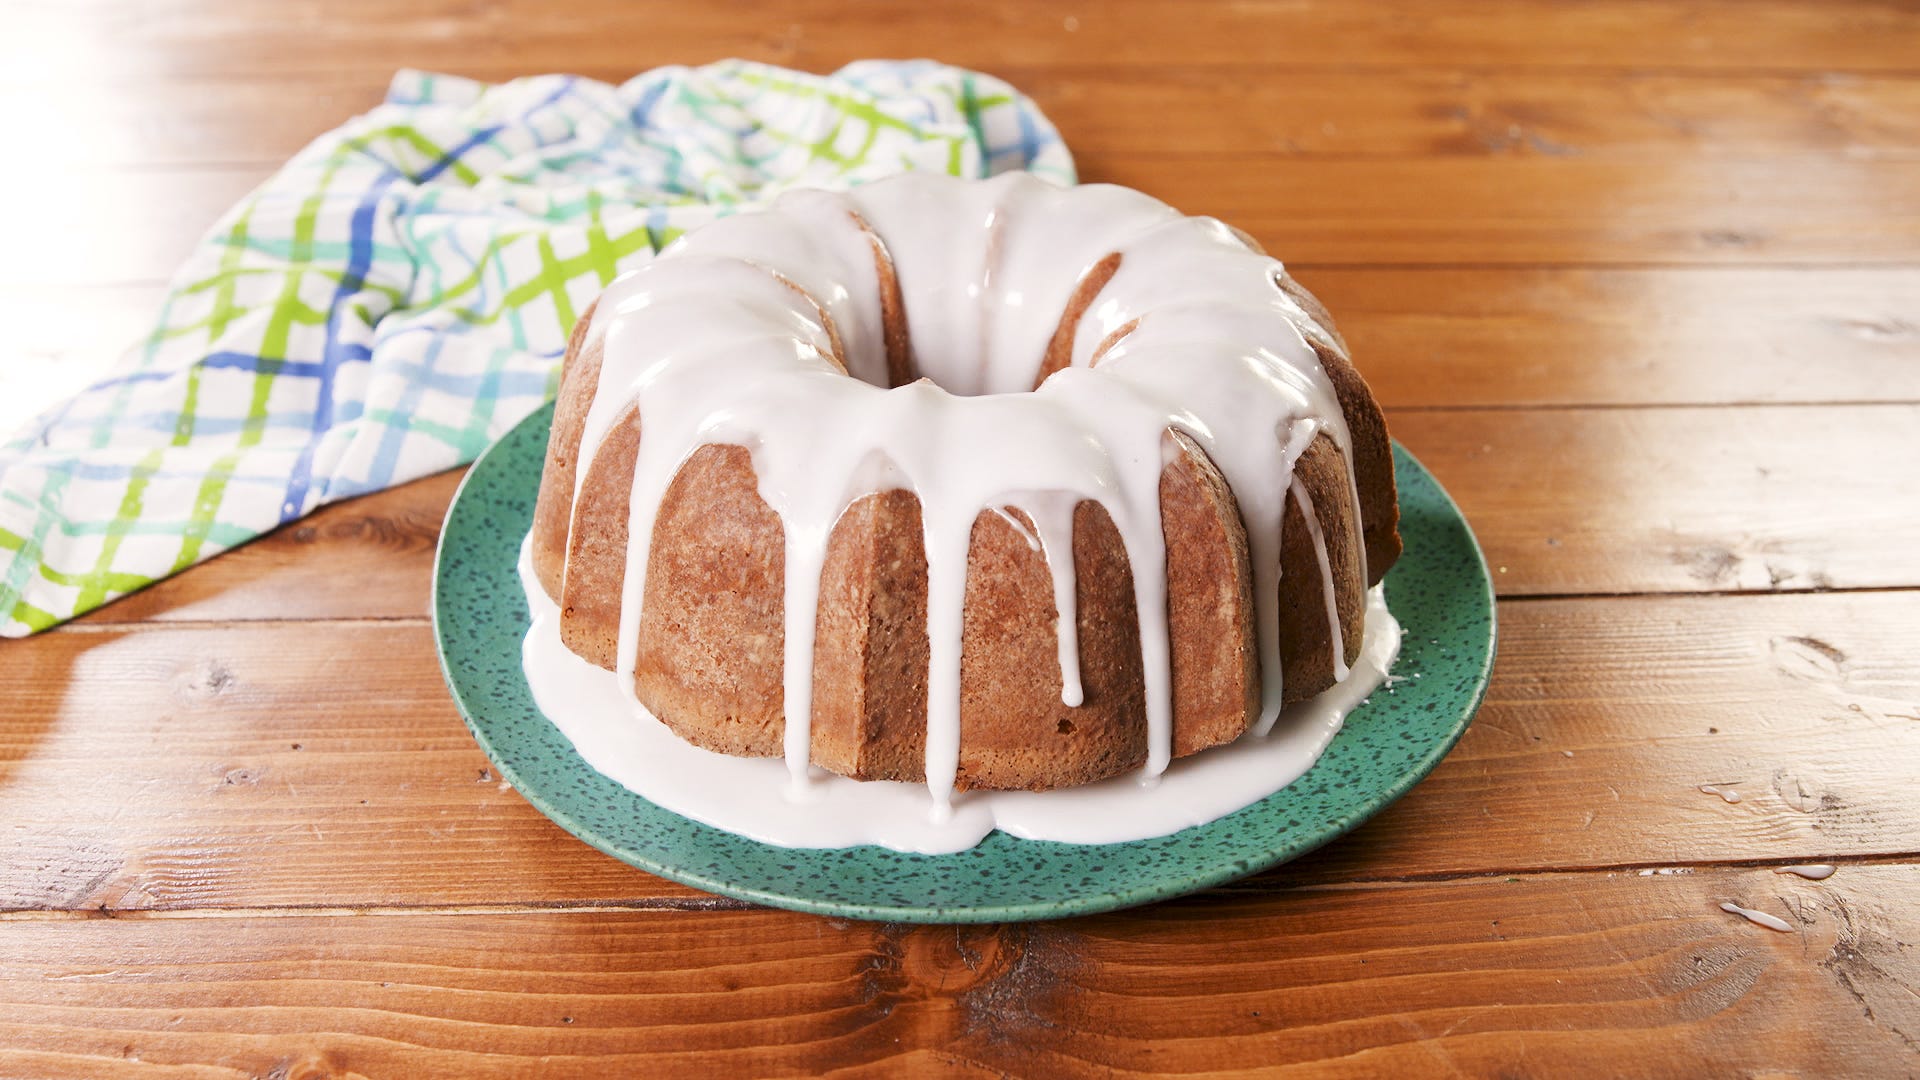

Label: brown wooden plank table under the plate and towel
[0,0,1920,1078]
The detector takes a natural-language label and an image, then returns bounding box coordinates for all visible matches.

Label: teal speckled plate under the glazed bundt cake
[434,405,1494,922]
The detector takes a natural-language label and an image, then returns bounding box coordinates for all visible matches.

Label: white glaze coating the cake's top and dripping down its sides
[556,173,1365,819]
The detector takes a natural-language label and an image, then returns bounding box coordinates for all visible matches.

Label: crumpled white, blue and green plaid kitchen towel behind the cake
[0,61,1073,636]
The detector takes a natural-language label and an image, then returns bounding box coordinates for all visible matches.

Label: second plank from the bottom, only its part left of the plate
[0,623,701,909]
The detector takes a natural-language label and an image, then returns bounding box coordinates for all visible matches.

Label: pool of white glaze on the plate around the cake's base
[520,544,1400,855]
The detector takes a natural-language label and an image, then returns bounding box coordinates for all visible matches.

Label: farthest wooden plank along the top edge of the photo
[22,0,1920,79]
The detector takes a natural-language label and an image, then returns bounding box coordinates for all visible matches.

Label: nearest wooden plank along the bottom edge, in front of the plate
[0,867,1920,1078]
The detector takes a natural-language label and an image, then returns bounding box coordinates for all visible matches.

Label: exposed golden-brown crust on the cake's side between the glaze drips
[563,432,1365,790]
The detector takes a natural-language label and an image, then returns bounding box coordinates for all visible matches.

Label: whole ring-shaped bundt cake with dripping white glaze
[528,173,1400,807]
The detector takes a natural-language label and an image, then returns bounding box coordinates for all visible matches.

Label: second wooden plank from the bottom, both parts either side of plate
[15,592,1920,911]
